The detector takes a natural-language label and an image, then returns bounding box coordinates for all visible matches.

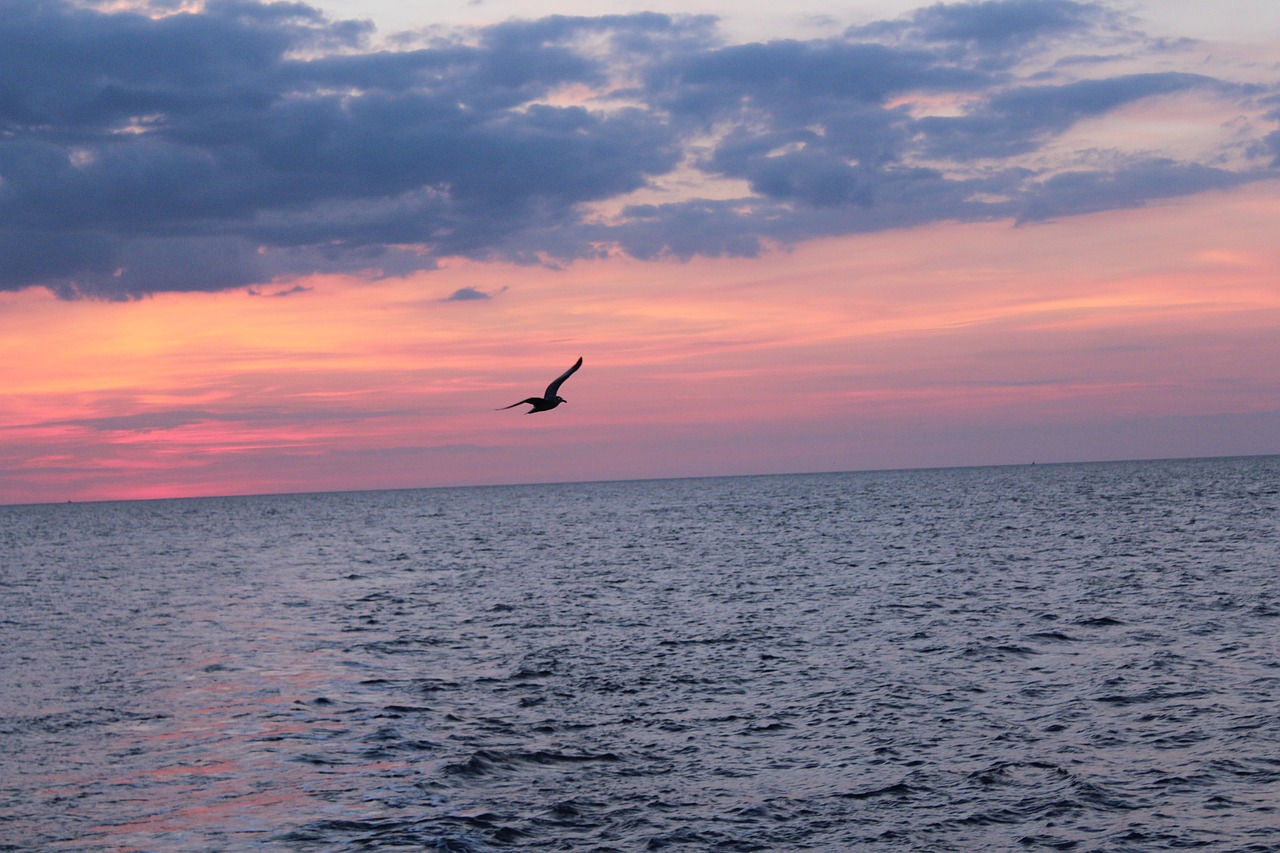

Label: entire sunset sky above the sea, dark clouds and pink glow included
[0,0,1280,503]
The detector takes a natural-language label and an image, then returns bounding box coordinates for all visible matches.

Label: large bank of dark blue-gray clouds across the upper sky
[0,0,1280,298]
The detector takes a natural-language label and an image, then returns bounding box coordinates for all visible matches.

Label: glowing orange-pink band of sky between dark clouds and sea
[0,182,1280,503]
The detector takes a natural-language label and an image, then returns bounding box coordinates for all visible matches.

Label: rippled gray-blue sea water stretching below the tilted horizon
[0,457,1280,852]
